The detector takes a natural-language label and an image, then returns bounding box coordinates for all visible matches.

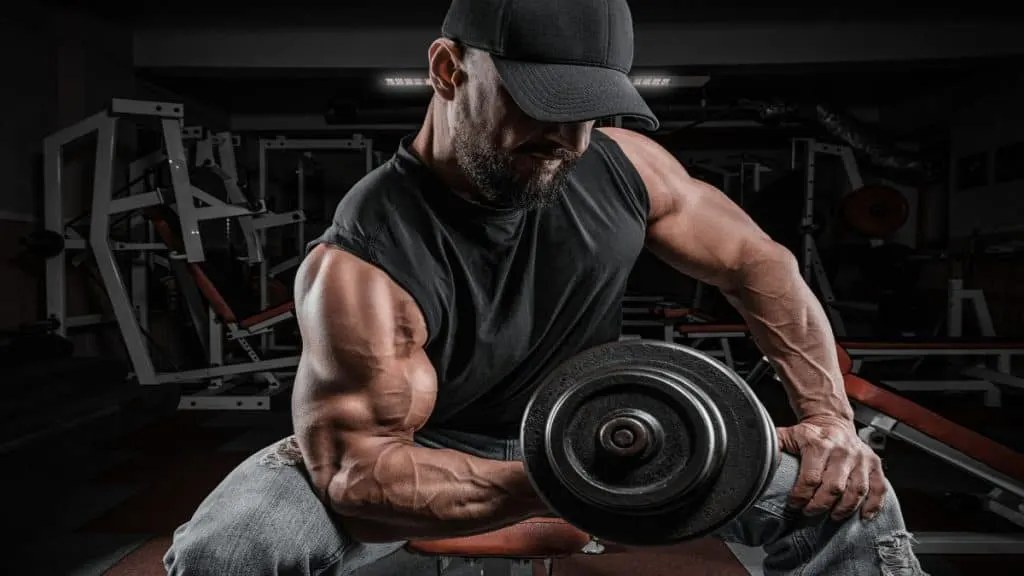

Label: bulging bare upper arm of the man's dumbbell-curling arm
[292,247,436,489]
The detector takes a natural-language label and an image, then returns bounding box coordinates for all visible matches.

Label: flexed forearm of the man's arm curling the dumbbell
[328,444,545,542]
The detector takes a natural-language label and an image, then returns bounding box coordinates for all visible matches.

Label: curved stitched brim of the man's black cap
[492,56,658,130]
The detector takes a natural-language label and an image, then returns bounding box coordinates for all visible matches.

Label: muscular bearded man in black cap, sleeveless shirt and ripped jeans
[165,0,922,576]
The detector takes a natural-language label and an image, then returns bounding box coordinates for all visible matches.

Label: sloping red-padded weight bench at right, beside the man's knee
[838,346,1024,553]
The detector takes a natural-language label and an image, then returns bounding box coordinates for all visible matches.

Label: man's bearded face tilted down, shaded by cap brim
[449,48,594,209]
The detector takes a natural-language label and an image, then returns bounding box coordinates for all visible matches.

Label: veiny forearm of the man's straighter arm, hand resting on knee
[726,256,853,420]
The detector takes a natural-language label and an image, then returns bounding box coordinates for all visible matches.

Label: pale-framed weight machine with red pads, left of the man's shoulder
[44,99,298,410]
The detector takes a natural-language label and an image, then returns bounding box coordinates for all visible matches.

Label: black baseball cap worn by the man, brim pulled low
[441,0,658,130]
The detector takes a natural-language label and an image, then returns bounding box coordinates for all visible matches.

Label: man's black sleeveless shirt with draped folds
[309,130,648,439]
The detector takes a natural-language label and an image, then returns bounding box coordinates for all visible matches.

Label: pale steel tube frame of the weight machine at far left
[44,98,299,410]
